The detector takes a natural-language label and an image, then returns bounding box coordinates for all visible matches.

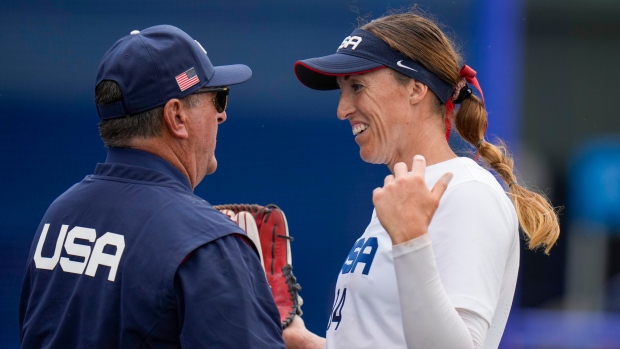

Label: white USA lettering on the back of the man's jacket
[34,223,125,282]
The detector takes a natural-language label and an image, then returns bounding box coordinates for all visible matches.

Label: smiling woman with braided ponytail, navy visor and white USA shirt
[284,8,559,349]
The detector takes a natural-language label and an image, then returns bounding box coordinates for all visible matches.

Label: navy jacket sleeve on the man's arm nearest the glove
[175,235,284,348]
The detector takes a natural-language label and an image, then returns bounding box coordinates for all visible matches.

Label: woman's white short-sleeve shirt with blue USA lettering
[326,158,519,349]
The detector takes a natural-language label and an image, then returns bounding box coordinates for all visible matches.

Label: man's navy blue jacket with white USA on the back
[19,149,284,348]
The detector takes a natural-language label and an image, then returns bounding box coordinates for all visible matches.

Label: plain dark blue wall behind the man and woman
[0,0,512,348]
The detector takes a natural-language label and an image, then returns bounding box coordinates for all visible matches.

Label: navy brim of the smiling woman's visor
[295,53,384,90]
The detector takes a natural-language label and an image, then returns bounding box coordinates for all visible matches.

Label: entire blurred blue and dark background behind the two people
[0,0,620,348]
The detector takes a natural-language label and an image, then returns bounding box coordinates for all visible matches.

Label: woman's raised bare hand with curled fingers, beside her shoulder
[372,155,452,245]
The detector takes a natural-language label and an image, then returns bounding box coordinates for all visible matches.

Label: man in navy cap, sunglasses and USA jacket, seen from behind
[19,25,284,348]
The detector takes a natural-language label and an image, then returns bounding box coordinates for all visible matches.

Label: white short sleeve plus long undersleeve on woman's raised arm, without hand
[393,182,517,348]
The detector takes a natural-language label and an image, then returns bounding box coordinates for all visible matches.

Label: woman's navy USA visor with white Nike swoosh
[295,29,454,104]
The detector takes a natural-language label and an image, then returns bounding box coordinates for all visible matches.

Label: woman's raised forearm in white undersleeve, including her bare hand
[373,156,489,348]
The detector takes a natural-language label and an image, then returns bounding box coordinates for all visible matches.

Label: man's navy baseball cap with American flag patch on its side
[95,25,252,119]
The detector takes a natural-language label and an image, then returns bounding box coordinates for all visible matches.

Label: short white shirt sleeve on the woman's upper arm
[429,181,518,324]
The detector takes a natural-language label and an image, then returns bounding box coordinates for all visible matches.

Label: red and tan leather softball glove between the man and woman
[214,204,302,328]
